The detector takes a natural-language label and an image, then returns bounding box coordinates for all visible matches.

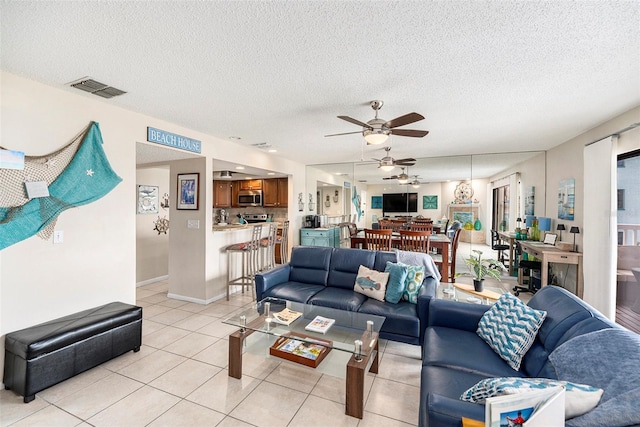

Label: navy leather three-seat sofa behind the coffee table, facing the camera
[256,246,439,344]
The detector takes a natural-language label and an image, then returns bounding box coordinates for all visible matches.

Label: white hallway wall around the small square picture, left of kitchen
[136,167,170,286]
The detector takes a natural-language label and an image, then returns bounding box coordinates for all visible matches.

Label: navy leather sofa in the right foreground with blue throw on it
[419,286,640,427]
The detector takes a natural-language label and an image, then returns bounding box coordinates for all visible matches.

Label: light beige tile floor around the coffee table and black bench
[5,282,421,427]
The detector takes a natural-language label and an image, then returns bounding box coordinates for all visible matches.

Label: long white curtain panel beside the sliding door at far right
[580,136,617,320]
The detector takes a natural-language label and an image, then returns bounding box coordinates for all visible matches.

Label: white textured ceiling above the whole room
[0,0,640,182]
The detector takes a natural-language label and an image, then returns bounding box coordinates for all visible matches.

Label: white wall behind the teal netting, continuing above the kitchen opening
[0,72,305,378]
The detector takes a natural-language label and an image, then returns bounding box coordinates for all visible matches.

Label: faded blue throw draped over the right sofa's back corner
[549,328,640,427]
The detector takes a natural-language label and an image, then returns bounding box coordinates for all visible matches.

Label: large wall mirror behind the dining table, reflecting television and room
[306,151,546,256]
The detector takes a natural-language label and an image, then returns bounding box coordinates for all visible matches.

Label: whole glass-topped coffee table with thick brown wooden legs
[223,298,385,419]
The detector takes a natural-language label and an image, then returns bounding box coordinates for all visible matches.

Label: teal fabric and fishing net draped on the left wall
[0,122,122,250]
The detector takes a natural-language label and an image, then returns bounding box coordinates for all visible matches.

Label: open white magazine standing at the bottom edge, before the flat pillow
[485,387,565,427]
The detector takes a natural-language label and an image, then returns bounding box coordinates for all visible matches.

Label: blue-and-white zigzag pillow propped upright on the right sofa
[476,293,547,371]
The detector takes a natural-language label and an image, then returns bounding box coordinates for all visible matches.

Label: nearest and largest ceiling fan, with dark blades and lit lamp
[325,100,429,145]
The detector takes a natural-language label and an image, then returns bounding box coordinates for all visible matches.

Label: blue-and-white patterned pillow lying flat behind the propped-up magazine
[460,377,604,420]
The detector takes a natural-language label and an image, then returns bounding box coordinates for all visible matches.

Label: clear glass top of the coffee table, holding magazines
[223,298,385,354]
